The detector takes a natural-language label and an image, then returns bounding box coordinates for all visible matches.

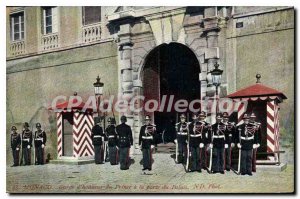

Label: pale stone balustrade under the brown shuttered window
[82,23,101,43]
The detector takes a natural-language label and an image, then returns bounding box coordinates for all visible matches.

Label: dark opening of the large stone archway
[141,43,200,145]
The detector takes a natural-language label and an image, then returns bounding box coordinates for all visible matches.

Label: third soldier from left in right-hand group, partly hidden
[199,111,211,169]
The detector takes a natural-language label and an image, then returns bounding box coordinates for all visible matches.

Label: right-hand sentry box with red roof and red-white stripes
[227,74,287,164]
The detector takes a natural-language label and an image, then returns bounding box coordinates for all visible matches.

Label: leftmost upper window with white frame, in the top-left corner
[10,12,24,41]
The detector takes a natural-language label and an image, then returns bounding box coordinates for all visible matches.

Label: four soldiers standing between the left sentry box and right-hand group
[91,116,156,171]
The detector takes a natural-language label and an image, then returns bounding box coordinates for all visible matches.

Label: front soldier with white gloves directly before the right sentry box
[236,114,258,176]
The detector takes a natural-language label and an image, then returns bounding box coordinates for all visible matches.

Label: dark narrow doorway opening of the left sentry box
[62,113,73,157]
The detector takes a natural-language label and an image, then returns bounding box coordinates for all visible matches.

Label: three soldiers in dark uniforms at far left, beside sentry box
[10,122,47,167]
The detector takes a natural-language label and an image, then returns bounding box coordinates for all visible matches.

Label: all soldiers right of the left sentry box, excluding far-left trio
[92,112,261,175]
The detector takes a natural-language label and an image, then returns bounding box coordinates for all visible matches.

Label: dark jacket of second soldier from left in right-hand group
[189,121,206,147]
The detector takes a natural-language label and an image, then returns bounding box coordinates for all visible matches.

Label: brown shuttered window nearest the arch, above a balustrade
[82,6,101,25]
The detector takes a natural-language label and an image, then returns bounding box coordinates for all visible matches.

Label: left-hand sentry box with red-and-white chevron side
[49,93,94,163]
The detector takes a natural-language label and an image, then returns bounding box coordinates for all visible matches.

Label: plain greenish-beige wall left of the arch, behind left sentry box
[6,42,118,164]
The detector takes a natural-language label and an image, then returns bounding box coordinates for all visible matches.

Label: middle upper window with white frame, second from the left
[43,7,58,34]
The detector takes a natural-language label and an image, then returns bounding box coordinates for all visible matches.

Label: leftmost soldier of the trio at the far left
[10,126,21,167]
